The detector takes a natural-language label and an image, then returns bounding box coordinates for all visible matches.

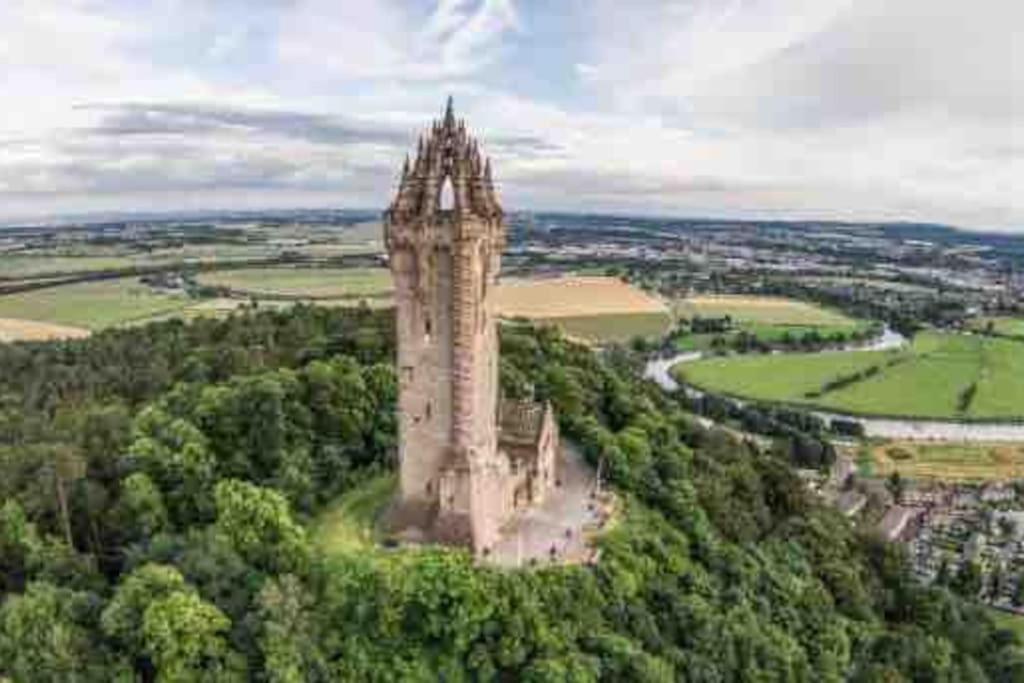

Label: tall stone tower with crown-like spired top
[384,97,513,552]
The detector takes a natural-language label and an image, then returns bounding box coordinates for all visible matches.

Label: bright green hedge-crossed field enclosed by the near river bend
[673,332,1024,420]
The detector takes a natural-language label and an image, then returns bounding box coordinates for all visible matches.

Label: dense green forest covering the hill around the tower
[0,306,1024,682]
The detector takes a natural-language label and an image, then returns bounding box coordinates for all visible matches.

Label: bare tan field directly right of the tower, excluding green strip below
[498,276,668,318]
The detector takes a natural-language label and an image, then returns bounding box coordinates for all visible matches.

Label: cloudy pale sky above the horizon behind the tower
[0,0,1024,231]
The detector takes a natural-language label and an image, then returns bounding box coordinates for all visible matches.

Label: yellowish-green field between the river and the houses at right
[870,441,1024,481]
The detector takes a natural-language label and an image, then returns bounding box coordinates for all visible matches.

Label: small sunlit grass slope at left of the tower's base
[311,473,397,555]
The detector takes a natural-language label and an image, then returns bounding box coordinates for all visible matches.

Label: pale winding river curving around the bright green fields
[643,328,1024,441]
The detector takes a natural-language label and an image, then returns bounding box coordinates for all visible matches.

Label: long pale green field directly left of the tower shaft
[199,267,392,299]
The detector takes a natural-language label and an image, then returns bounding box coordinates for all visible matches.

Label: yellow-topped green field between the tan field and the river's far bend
[675,295,870,350]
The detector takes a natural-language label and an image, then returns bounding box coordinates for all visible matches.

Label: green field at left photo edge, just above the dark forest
[0,278,190,330]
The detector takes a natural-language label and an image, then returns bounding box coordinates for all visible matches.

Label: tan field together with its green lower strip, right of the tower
[498,276,671,341]
